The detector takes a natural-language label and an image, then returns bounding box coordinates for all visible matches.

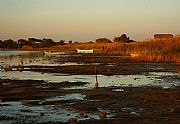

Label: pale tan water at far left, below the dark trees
[0,51,86,66]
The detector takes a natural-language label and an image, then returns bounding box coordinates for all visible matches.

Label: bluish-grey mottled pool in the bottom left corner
[1,102,102,124]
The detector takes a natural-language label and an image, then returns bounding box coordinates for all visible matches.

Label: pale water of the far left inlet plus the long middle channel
[0,51,180,89]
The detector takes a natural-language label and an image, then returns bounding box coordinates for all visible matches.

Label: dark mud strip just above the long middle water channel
[11,63,180,75]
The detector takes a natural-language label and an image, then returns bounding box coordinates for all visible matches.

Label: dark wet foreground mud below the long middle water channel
[0,80,180,124]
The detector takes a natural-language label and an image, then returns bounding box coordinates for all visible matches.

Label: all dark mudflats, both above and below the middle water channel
[0,53,180,124]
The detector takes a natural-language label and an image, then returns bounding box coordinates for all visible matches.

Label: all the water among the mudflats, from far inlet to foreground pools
[0,51,180,124]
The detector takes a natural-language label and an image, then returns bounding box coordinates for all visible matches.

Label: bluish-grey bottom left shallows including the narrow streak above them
[0,94,115,124]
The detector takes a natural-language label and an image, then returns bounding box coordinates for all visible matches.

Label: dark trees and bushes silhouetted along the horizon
[0,34,133,49]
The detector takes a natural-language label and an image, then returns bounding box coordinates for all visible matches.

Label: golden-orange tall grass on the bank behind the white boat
[42,37,180,63]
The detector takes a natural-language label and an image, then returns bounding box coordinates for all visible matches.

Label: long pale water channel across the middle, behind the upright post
[0,71,180,89]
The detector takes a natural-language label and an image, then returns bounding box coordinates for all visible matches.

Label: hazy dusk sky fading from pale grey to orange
[0,0,180,41]
